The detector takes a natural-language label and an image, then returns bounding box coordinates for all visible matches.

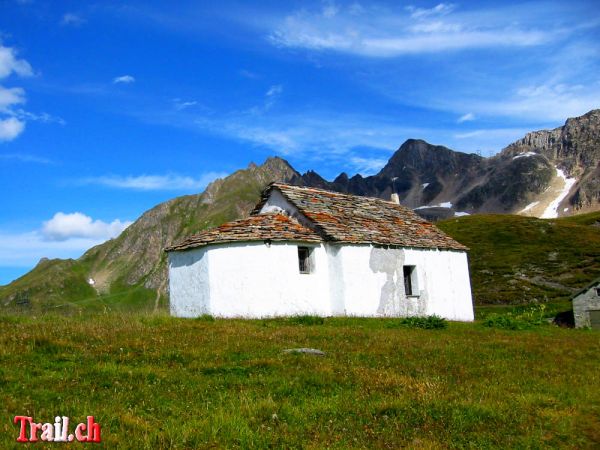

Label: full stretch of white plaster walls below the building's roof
[169,242,473,321]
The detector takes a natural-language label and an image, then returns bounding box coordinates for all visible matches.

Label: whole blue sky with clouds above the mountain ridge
[0,0,600,284]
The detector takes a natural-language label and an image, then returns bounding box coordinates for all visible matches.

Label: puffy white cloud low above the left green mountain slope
[41,212,132,241]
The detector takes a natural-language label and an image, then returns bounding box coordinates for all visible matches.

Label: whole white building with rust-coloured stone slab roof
[167,183,473,321]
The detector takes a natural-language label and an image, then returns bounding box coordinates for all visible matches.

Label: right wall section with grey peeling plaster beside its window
[330,245,474,321]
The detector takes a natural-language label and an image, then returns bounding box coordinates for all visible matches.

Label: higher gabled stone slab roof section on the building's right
[252,183,468,250]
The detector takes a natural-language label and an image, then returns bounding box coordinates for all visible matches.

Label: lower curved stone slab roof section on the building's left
[165,214,323,252]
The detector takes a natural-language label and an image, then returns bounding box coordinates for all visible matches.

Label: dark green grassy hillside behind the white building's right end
[436,212,600,304]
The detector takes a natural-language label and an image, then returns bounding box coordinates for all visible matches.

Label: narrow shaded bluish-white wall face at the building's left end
[169,247,210,317]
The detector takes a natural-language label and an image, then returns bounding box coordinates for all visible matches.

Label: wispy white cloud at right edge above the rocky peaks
[370,41,600,124]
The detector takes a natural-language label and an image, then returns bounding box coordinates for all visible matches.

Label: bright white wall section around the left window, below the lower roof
[209,242,331,317]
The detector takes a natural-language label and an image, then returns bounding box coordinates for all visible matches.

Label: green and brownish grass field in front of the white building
[0,314,600,448]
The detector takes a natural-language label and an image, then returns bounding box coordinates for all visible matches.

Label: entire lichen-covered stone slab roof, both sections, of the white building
[166,183,467,251]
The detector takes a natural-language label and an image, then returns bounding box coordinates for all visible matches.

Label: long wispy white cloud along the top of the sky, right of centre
[269,3,562,58]
